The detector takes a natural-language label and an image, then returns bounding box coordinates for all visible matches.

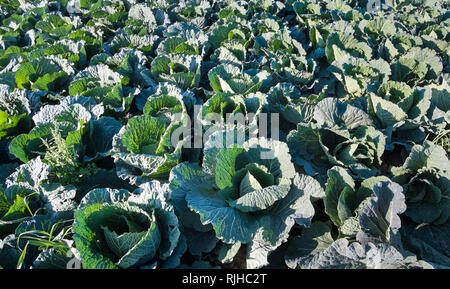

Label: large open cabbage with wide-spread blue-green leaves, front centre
[170,131,323,264]
